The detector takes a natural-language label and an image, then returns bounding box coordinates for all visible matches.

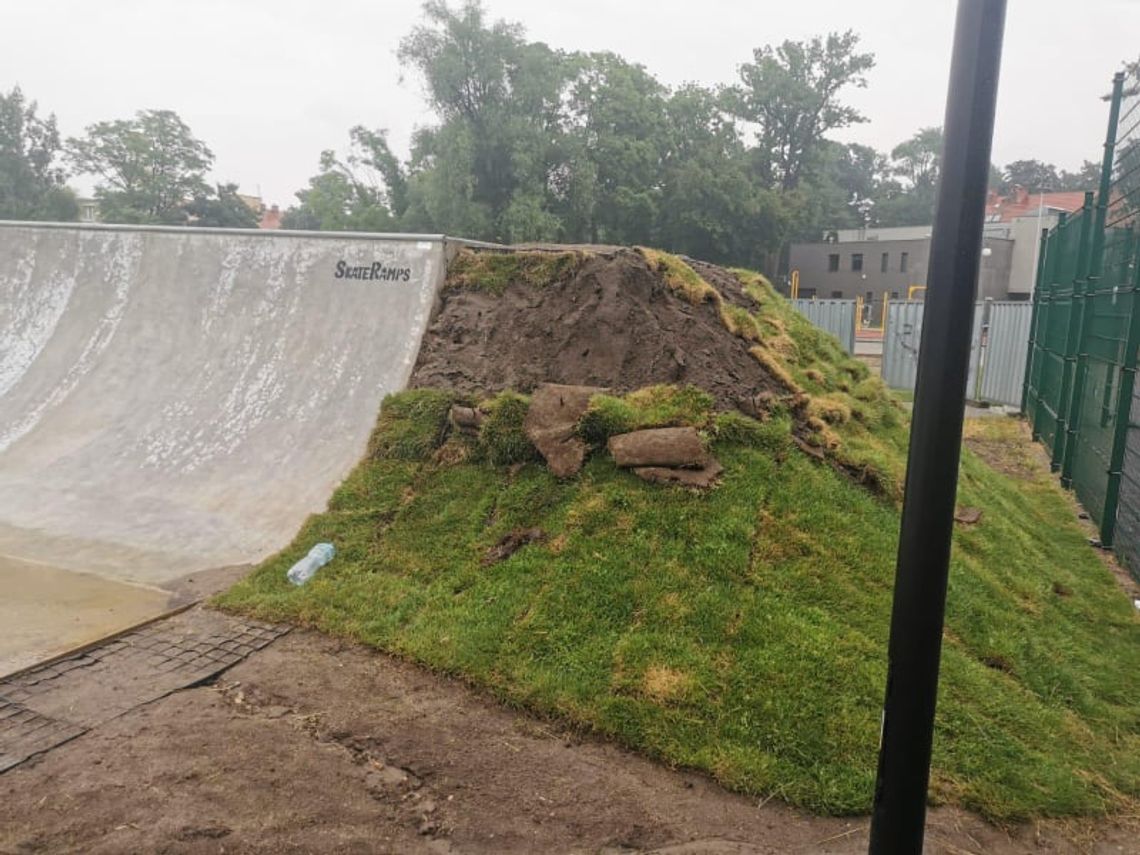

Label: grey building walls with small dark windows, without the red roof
[789,236,1019,326]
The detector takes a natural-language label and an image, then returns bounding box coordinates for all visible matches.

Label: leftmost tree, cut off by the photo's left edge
[0,87,79,221]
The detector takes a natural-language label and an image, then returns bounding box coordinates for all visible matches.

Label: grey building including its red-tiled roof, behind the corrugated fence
[789,187,1084,326]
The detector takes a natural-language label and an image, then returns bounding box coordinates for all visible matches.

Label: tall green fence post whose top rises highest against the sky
[1061,72,1124,492]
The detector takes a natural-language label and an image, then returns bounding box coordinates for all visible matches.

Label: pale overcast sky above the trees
[0,0,1140,206]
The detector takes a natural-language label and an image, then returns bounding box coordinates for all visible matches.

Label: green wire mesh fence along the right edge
[1023,73,1140,564]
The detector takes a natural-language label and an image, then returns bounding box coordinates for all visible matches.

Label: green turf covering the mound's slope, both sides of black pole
[218,405,1140,820]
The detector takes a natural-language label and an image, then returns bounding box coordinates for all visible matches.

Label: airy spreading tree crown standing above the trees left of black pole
[727,31,874,190]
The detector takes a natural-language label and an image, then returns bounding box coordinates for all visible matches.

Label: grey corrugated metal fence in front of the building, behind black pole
[882,300,1033,407]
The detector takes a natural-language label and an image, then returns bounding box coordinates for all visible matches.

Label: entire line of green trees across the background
[0,0,1097,267]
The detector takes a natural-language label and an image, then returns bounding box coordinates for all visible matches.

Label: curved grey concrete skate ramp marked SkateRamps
[0,223,446,592]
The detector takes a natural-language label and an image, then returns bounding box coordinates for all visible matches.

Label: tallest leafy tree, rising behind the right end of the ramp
[399,0,571,241]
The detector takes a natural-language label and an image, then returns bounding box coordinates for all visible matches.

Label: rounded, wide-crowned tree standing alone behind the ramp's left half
[67,109,213,223]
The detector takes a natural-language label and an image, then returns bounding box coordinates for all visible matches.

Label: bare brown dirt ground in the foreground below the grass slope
[0,615,1140,855]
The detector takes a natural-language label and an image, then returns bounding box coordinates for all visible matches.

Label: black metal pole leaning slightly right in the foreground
[870,0,1005,855]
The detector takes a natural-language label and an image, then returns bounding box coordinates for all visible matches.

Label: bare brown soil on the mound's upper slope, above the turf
[410,249,787,408]
